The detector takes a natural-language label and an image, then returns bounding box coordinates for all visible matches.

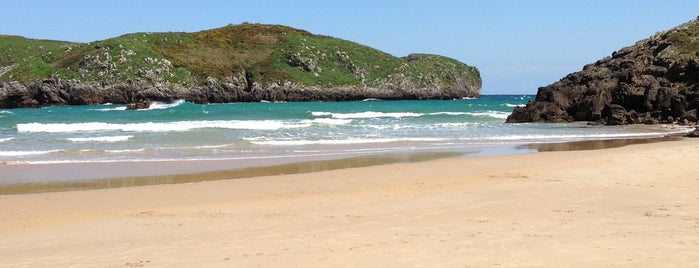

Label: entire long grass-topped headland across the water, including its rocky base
[0,23,481,108]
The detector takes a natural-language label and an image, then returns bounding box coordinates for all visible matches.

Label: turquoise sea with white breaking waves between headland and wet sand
[0,95,687,164]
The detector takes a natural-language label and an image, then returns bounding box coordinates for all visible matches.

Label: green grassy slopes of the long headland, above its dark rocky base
[0,23,480,88]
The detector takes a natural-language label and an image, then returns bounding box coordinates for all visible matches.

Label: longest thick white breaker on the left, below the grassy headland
[17,120,311,133]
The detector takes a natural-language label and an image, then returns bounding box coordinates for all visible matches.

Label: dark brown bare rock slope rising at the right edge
[507,19,699,125]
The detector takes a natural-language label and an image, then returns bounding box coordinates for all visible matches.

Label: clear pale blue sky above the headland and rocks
[0,0,699,94]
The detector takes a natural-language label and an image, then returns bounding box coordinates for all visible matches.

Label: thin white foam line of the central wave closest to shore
[252,138,444,146]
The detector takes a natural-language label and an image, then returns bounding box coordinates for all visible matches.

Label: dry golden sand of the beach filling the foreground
[0,140,699,267]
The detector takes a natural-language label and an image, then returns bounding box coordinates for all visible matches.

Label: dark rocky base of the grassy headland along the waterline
[0,75,480,109]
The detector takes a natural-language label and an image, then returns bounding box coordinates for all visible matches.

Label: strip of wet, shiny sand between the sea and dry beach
[0,135,682,195]
